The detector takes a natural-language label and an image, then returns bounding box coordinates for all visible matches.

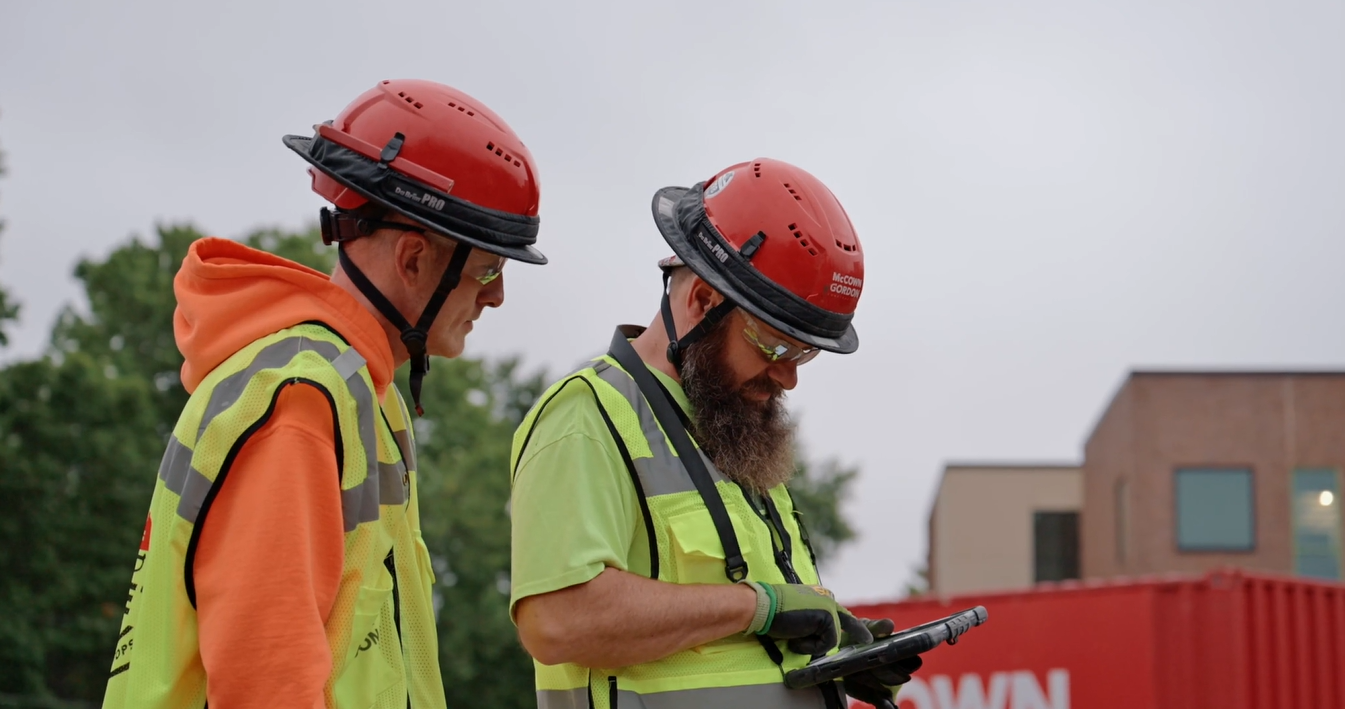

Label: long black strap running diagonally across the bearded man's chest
[608,330,748,583]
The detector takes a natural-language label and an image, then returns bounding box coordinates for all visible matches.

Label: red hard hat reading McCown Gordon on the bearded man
[654,157,863,354]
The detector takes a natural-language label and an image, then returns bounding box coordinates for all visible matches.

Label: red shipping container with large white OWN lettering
[850,569,1345,709]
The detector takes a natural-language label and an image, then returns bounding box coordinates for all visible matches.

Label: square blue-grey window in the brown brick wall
[1177,468,1256,552]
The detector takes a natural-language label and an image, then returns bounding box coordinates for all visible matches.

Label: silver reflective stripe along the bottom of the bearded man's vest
[537,683,826,709]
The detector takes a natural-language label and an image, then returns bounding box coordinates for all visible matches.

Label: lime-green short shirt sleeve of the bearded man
[510,386,648,615]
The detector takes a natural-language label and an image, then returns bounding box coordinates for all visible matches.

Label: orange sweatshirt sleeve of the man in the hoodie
[195,385,344,709]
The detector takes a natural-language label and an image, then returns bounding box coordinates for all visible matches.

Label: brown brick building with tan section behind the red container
[929,371,1345,593]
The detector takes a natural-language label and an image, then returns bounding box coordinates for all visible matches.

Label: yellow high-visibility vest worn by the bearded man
[511,334,824,709]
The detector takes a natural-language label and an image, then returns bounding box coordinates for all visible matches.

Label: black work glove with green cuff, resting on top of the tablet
[744,581,866,657]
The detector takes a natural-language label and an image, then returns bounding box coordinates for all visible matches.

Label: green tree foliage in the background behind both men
[0,225,855,709]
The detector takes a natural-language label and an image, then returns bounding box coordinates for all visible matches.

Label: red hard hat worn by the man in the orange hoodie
[284,79,546,264]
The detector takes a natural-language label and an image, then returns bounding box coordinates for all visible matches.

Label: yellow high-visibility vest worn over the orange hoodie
[104,324,444,709]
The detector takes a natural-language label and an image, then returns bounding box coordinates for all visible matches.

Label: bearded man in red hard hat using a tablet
[511,159,919,709]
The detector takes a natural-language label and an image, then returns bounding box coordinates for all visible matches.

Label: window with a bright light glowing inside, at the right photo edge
[1293,470,1341,581]
